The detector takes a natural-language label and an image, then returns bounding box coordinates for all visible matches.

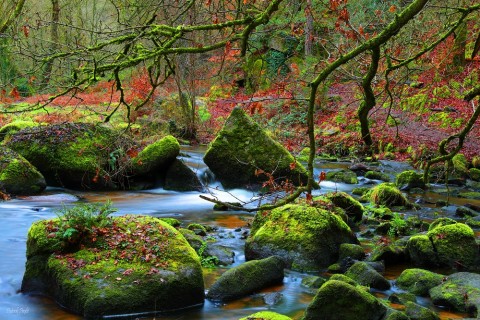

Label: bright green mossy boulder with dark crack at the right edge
[407,223,480,268]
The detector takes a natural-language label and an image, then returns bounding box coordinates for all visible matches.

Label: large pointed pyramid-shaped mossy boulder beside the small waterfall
[204,107,308,189]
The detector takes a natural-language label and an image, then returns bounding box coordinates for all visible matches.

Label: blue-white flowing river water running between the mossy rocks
[0,148,478,320]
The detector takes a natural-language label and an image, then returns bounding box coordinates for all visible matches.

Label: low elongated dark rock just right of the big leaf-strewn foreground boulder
[207,256,284,301]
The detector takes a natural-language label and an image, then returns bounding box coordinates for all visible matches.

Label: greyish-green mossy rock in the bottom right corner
[429,272,480,317]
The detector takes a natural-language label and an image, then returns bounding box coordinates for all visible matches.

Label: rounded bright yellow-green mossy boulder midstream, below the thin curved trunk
[245,204,358,271]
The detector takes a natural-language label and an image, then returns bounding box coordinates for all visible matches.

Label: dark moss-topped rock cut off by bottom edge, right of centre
[302,280,387,320]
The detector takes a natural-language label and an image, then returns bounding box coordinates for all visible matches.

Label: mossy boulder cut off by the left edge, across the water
[0,148,47,195]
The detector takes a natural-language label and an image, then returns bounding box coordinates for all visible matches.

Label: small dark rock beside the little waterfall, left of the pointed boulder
[163,159,203,191]
